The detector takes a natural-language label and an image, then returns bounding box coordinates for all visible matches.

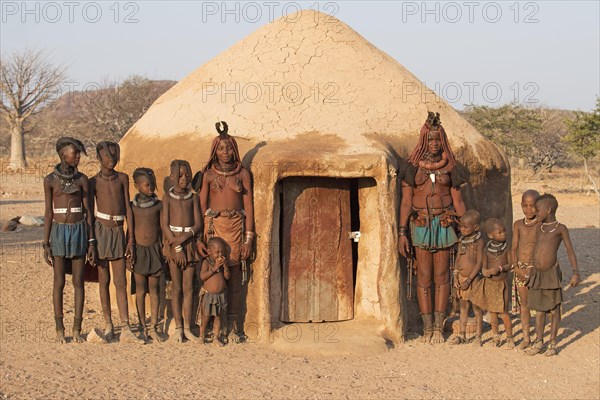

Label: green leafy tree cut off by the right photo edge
[564,97,600,198]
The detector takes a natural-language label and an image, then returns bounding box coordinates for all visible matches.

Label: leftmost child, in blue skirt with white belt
[42,137,92,343]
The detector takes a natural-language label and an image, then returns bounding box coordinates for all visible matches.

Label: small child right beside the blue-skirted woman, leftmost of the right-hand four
[450,210,483,346]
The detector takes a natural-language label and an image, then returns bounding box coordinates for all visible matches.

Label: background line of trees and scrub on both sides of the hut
[0,49,600,194]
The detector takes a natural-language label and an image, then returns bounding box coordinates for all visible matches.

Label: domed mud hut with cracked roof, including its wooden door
[121,10,512,342]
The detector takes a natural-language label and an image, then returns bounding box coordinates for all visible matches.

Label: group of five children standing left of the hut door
[43,137,230,345]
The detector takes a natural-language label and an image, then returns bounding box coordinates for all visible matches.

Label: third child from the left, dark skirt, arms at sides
[129,168,165,342]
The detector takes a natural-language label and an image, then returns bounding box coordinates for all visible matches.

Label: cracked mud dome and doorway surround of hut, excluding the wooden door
[119,10,512,342]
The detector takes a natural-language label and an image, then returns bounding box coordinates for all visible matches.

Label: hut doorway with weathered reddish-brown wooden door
[280,177,359,322]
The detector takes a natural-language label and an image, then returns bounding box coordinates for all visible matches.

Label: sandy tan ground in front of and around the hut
[0,173,600,399]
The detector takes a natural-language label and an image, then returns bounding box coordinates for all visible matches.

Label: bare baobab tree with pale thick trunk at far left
[0,49,65,169]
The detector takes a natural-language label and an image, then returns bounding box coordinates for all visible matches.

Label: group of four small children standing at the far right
[450,190,581,356]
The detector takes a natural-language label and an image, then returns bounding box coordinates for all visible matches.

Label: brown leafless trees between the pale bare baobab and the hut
[82,75,173,141]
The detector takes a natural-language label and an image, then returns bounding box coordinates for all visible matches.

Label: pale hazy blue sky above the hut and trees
[0,1,600,110]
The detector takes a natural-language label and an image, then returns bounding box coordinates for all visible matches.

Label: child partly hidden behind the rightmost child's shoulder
[511,189,541,350]
